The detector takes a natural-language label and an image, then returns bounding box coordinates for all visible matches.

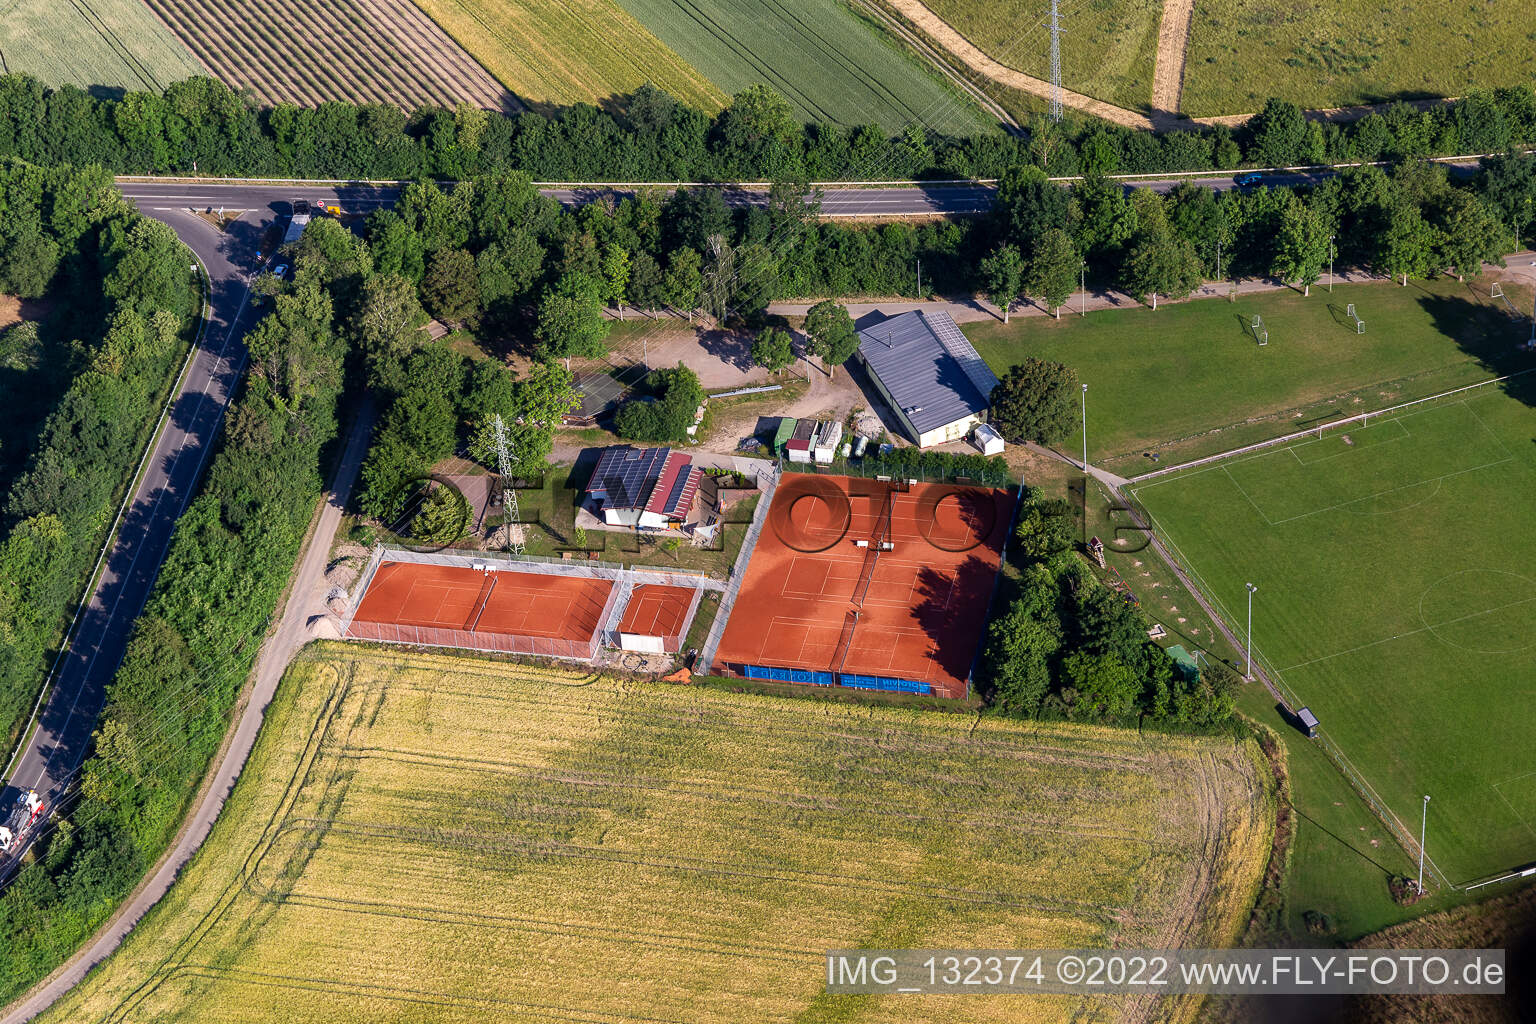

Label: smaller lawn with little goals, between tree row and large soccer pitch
[965,279,1530,476]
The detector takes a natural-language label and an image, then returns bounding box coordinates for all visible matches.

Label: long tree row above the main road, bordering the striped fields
[0,74,1536,181]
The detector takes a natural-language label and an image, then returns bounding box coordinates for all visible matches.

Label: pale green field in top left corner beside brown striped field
[0,0,204,92]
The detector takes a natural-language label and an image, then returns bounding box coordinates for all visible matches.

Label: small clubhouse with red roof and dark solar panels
[587,445,703,530]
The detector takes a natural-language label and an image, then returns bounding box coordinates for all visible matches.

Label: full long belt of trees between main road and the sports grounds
[330,152,1536,388]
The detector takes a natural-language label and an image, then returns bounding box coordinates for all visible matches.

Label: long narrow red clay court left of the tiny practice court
[347,562,613,659]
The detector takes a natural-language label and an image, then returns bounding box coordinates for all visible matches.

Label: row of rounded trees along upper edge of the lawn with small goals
[969,152,1517,319]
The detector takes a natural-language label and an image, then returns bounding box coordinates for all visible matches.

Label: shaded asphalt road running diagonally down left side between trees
[0,209,261,870]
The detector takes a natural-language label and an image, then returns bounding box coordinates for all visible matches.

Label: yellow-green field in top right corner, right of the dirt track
[1181,0,1536,117]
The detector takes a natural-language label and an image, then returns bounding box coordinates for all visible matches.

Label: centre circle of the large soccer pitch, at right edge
[1419,570,1536,654]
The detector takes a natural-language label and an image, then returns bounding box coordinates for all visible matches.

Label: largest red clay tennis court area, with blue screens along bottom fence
[714,474,1014,697]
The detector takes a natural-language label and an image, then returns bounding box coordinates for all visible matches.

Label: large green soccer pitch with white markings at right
[1129,382,1536,883]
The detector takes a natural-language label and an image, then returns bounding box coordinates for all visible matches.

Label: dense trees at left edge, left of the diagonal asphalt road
[0,160,200,751]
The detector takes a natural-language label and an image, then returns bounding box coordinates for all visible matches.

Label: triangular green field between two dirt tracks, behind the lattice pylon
[897,0,1163,111]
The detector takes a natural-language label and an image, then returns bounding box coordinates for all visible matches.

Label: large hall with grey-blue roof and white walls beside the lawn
[854,310,997,448]
